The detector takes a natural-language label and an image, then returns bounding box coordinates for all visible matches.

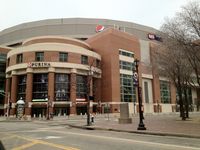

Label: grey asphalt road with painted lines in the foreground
[0,121,200,150]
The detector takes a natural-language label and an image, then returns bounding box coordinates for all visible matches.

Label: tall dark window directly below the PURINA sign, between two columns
[33,74,48,100]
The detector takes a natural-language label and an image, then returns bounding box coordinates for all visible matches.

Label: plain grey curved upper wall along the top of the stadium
[0,18,157,45]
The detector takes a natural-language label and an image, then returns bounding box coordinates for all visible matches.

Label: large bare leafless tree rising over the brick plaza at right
[157,1,200,119]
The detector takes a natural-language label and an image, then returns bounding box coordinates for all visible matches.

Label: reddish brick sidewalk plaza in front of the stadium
[60,113,200,138]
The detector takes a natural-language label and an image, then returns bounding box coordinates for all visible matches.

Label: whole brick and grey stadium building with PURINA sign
[0,18,198,117]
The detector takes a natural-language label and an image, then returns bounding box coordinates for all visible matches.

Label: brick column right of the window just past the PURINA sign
[70,69,76,114]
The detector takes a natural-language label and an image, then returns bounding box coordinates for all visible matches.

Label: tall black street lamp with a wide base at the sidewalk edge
[133,59,146,130]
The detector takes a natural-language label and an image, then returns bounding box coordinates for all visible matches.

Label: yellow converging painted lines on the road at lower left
[7,134,80,150]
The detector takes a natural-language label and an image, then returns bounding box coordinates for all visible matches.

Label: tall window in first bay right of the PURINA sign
[55,73,70,101]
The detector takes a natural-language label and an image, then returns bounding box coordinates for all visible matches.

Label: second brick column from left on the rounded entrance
[10,72,18,115]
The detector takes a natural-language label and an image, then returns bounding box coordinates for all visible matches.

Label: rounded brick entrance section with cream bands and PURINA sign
[5,37,101,117]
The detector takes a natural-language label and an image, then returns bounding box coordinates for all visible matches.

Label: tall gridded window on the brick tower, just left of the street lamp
[120,74,136,102]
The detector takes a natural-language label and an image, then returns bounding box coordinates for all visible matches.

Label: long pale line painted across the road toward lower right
[48,130,200,150]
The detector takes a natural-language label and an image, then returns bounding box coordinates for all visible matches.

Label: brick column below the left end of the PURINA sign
[25,70,33,117]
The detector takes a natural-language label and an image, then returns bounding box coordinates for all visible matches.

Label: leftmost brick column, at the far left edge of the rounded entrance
[4,78,11,114]
